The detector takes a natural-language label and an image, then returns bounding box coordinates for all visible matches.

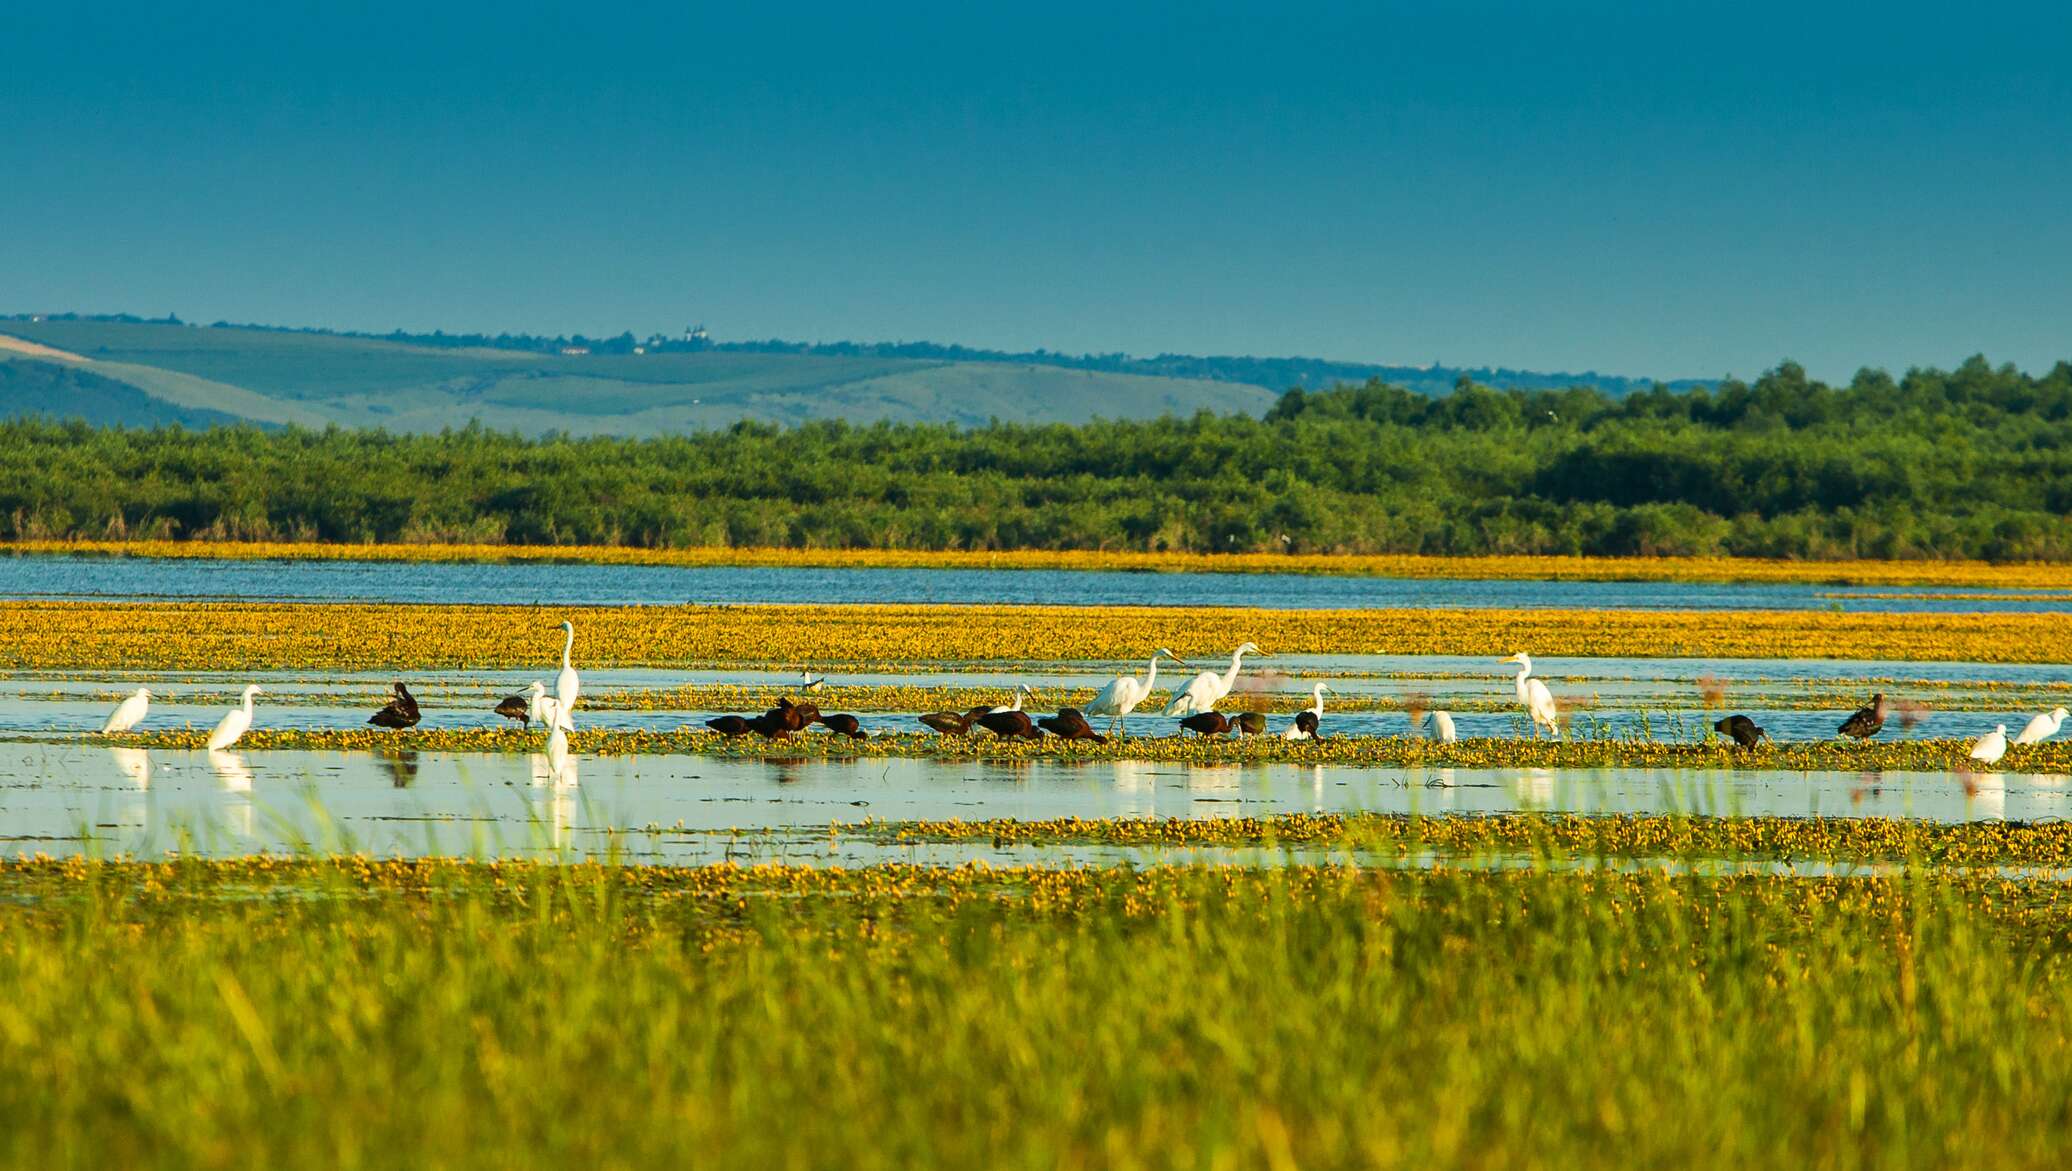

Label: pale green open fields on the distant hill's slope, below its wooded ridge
[0,321,1274,435]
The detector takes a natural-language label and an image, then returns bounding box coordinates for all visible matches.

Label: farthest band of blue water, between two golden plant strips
[0,555,2072,613]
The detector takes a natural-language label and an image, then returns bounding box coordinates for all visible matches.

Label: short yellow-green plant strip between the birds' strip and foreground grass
[853,812,2072,868]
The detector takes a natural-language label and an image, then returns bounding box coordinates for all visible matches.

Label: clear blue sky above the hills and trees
[0,0,2072,377]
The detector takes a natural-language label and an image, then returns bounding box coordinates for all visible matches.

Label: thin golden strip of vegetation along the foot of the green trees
[12,541,2072,589]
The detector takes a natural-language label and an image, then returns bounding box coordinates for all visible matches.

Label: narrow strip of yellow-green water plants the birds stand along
[95,725,2072,775]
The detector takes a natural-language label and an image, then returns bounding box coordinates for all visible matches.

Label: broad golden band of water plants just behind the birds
[0,601,2068,672]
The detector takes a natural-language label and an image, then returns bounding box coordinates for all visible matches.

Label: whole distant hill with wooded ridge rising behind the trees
[0,315,1707,435]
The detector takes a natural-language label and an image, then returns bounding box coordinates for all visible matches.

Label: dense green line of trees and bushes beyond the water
[0,359,2072,560]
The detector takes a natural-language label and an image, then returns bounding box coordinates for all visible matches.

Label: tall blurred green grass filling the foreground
[0,860,2072,1171]
